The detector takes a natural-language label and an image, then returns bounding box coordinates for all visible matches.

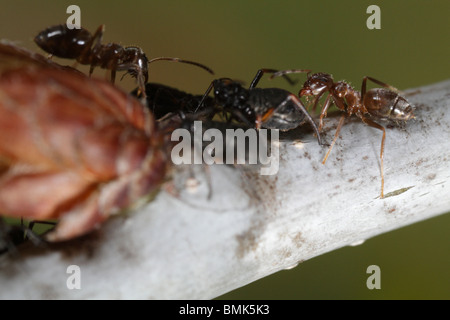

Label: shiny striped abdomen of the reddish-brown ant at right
[363,88,414,121]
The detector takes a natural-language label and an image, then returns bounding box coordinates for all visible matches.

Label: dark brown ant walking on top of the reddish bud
[34,24,214,98]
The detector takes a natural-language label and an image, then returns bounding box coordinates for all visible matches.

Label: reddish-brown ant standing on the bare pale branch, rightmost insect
[272,70,414,198]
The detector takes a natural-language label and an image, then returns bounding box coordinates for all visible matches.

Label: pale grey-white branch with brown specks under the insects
[0,81,450,299]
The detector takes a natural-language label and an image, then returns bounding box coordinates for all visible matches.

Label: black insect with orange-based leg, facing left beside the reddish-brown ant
[197,69,323,145]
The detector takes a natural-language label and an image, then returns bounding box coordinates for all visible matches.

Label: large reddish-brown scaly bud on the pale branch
[0,44,168,241]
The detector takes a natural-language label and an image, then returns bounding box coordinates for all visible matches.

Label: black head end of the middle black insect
[213,78,248,109]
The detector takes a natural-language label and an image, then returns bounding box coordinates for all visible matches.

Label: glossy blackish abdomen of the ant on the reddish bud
[34,24,92,59]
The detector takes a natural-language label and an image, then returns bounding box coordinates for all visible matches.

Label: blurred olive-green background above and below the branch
[0,0,450,299]
